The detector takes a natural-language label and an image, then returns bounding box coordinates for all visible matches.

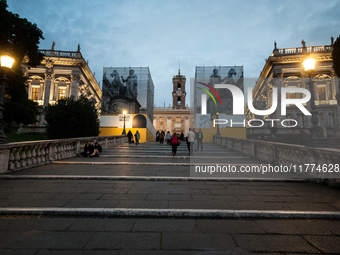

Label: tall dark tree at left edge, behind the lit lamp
[0,0,44,125]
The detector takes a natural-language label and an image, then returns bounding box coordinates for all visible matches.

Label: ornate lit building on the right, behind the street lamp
[245,38,340,138]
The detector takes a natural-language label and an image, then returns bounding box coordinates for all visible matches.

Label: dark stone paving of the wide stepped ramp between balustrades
[0,143,340,255]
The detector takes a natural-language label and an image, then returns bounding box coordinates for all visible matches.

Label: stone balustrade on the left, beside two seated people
[0,135,127,173]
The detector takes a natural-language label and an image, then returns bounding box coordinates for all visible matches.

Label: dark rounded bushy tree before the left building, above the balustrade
[44,96,99,139]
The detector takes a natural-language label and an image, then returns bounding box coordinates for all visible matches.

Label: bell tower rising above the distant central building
[172,70,186,109]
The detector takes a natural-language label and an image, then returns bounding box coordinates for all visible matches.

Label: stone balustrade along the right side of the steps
[214,136,340,166]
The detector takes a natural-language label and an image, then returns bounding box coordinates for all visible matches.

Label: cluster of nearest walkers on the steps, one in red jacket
[168,128,203,156]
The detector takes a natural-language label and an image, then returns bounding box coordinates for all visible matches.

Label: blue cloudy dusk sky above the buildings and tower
[7,0,340,106]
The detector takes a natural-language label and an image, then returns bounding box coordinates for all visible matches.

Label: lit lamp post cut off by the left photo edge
[0,54,14,144]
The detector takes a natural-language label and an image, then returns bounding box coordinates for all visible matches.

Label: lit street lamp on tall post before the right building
[302,54,328,147]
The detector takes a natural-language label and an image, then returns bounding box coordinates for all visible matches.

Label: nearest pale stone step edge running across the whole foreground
[0,207,340,220]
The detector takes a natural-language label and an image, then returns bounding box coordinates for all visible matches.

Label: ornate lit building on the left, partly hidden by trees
[22,43,102,127]
